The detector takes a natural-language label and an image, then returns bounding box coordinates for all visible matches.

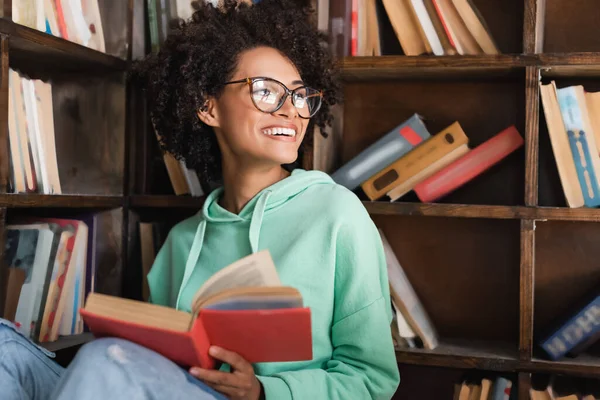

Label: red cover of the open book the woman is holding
[80,308,312,368]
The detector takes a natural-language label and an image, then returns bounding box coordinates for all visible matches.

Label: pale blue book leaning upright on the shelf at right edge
[556,86,600,207]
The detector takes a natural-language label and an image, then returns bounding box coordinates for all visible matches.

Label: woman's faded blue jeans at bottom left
[0,318,226,400]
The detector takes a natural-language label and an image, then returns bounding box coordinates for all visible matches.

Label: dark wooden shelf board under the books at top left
[0,18,127,76]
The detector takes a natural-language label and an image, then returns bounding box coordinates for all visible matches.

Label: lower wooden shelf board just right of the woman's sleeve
[396,339,518,371]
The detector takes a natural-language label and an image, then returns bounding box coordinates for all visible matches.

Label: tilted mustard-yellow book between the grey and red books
[361,122,469,200]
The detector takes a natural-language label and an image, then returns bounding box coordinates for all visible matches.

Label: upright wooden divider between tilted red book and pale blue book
[525,67,540,206]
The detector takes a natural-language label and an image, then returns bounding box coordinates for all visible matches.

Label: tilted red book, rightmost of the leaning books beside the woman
[414,125,523,203]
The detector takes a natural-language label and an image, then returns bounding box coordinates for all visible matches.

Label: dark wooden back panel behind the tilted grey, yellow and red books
[341,79,525,205]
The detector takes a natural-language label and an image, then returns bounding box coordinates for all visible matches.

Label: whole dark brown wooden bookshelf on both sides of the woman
[0,0,600,400]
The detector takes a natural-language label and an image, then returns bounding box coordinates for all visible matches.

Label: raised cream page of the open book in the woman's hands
[192,250,281,310]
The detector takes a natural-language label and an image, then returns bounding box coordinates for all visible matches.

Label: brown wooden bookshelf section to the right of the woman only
[305,0,600,400]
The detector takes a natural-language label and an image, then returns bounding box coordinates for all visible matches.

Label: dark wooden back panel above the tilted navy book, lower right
[534,221,600,358]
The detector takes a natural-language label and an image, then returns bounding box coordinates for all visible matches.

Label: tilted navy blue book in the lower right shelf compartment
[541,296,600,360]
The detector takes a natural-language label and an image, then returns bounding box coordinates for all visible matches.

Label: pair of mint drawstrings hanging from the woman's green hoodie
[175,191,271,310]
